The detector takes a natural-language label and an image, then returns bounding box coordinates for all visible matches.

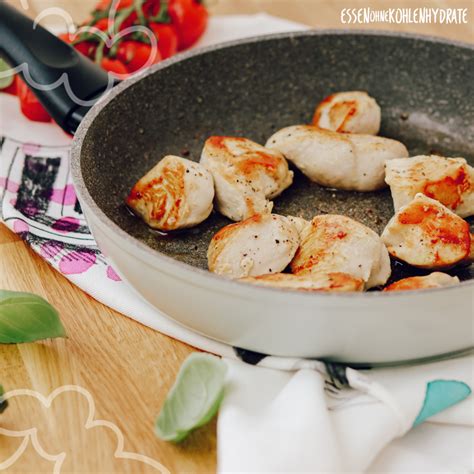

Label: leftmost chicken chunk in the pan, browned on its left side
[126,155,214,231]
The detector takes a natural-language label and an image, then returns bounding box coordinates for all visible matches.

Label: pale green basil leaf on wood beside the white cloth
[155,352,227,442]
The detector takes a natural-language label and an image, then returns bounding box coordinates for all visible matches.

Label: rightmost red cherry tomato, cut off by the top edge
[168,0,209,50]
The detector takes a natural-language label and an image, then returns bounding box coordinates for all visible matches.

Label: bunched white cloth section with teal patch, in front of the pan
[217,357,474,473]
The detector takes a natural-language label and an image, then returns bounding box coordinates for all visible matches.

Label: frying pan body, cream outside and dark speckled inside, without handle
[0,3,474,363]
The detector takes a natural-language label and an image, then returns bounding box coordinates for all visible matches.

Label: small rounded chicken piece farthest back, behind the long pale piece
[313,91,381,135]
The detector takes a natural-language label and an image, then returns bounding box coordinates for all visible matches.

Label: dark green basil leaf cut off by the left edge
[0,290,66,344]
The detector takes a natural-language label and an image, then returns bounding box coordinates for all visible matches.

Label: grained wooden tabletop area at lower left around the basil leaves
[0,225,215,473]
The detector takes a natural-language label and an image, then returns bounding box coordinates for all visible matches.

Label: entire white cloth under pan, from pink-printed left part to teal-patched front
[0,14,474,472]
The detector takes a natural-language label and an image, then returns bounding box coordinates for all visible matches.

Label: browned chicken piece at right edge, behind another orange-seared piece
[385,155,474,217]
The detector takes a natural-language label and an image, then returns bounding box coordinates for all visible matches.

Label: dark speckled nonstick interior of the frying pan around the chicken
[81,33,474,286]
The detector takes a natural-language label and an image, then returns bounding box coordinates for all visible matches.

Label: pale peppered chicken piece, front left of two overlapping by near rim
[207,214,300,278]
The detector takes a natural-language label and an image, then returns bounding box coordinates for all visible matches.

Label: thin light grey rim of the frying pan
[71,29,474,301]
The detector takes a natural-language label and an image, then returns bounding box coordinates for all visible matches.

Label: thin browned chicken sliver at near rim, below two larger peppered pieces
[241,273,364,291]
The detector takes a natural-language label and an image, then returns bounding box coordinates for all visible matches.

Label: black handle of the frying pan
[0,0,114,133]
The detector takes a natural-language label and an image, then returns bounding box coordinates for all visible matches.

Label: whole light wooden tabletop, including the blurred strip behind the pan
[0,0,474,473]
